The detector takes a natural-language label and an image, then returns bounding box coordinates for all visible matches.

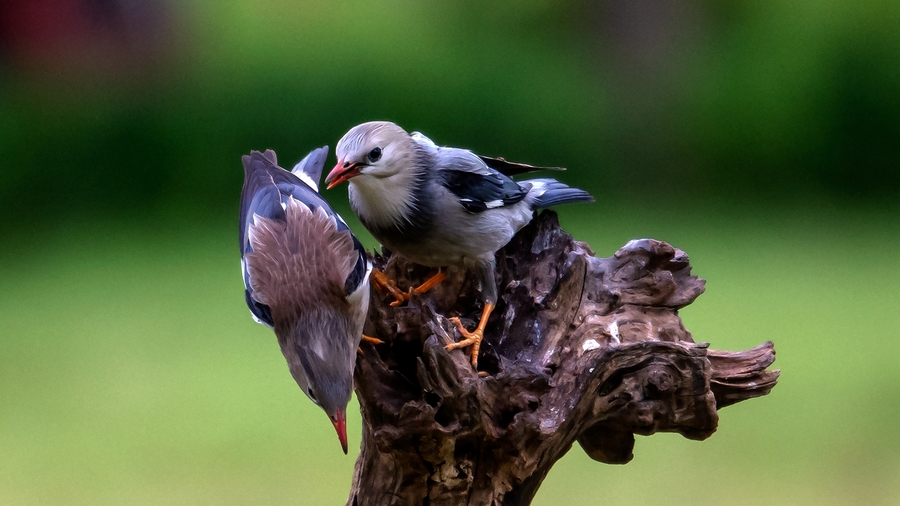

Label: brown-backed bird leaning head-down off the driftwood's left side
[240,146,372,454]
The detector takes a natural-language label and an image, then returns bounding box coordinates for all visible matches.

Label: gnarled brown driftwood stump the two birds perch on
[347,211,778,506]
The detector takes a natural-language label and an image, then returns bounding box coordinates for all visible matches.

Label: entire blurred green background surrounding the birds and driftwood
[0,0,900,506]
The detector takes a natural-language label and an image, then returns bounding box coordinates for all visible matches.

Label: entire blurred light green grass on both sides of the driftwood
[0,201,900,505]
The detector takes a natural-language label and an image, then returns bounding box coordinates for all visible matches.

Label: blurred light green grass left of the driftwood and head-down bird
[0,215,360,504]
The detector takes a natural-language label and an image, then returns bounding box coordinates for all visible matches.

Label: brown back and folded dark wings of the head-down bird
[240,148,366,326]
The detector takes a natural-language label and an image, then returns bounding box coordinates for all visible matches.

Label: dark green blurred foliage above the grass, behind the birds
[0,1,900,233]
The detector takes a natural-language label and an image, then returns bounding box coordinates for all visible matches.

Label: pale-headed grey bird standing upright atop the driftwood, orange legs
[325,121,594,370]
